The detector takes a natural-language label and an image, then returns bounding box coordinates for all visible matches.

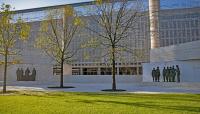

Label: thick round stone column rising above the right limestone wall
[149,0,160,49]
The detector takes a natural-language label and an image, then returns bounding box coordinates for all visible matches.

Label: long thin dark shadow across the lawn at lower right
[78,100,200,112]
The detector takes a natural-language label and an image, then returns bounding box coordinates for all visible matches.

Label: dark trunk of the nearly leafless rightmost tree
[112,48,116,90]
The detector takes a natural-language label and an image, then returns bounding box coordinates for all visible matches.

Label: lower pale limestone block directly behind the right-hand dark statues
[143,60,200,82]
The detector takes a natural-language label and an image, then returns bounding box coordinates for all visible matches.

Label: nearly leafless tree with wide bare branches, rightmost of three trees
[86,0,142,91]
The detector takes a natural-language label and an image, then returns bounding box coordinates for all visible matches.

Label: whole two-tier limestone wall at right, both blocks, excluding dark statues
[143,41,200,82]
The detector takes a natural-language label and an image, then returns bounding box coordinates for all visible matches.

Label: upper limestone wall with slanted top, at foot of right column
[150,41,200,62]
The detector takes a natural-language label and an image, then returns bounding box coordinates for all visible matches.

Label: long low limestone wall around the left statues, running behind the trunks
[0,64,142,85]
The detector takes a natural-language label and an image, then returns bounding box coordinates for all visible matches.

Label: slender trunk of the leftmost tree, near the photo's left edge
[3,49,8,93]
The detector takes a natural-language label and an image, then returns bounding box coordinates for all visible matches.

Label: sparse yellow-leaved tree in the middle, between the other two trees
[36,6,82,88]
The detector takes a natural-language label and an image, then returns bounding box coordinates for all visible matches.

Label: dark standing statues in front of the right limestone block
[152,65,180,82]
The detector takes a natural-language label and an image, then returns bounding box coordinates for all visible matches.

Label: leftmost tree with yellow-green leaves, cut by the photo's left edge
[0,4,30,93]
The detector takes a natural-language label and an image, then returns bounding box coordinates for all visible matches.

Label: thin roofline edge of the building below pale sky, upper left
[14,0,94,13]
